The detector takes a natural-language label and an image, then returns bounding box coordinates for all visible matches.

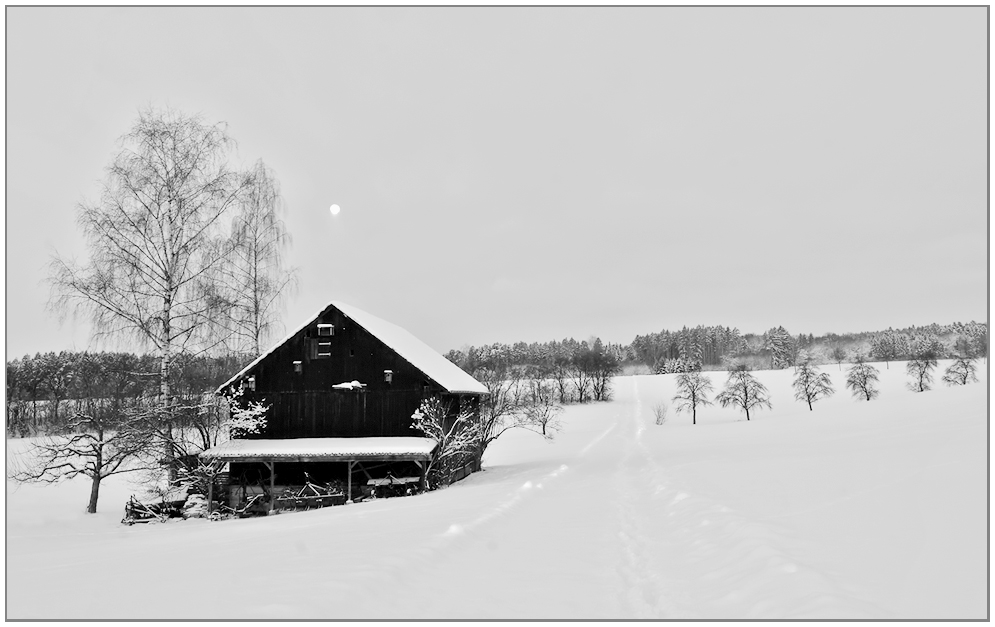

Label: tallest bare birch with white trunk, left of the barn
[50,108,250,478]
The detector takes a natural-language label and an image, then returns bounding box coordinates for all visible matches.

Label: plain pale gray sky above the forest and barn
[6,7,988,358]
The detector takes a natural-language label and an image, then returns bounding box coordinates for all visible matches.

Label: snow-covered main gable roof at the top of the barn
[217,301,487,394]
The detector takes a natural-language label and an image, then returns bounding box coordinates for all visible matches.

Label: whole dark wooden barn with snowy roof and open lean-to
[201,302,487,510]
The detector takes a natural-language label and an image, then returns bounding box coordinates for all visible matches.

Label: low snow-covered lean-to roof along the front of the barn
[200,437,436,461]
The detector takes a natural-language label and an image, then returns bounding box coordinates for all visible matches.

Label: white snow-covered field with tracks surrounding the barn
[7,362,988,619]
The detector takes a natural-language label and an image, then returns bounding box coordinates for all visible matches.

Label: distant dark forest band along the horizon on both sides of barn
[6,321,988,437]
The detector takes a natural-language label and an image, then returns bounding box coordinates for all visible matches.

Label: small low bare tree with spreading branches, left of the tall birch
[11,408,151,514]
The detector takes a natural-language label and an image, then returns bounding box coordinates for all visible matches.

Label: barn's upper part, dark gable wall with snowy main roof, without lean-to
[218,302,487,439]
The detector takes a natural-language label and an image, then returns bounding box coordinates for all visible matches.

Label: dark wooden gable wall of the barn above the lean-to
[237,306,478,439]
